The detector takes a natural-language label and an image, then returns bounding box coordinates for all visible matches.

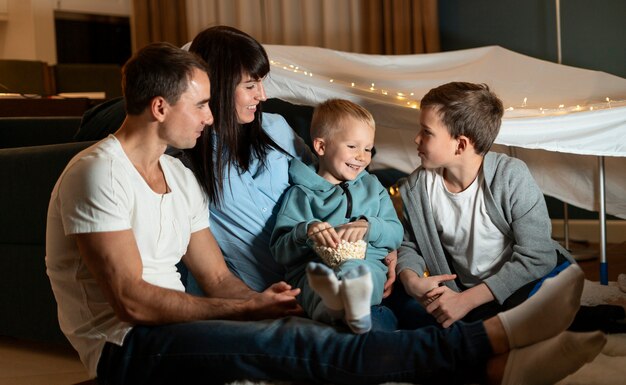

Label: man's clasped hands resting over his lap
[246,282,304,320]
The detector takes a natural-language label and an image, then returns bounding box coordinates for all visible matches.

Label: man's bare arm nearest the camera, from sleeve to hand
[74,229,295,324]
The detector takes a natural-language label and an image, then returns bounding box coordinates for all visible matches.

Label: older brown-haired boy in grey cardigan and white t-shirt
[397,82,573,327]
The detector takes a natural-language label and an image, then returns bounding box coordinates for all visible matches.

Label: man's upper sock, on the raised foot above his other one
[498,265,585,349]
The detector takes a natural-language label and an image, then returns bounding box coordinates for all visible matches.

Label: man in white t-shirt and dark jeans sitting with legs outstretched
[46,43,605,384]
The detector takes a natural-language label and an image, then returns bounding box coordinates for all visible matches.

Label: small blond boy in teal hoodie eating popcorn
[271,99,402,333]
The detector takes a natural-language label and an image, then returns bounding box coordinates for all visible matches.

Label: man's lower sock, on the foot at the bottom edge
[502,331,606,385]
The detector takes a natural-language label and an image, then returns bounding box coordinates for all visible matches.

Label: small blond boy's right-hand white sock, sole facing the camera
[340,265,374,334]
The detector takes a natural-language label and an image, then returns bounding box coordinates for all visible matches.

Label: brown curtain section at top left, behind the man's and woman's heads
[131,0,189,51]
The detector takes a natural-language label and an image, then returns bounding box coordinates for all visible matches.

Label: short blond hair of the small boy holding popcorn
[311,99,376,139]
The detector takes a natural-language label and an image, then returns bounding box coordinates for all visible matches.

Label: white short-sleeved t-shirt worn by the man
[46,135,209,377]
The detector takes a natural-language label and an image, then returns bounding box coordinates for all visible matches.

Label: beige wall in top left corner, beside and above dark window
[0,0,131,64]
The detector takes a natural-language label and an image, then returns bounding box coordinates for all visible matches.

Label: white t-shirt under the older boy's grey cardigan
[426,169,512,287]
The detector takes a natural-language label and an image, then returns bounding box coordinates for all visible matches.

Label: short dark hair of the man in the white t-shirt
[122,43,208,115]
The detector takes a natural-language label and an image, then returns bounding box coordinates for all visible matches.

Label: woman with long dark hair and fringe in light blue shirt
[188,26,313,291]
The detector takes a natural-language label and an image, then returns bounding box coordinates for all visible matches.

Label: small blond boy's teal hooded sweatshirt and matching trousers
[270,159,403,310]
